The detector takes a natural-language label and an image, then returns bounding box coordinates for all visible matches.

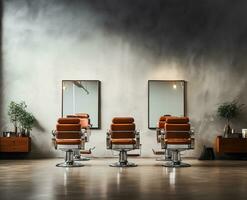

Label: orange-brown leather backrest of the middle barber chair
[110,117,136,139]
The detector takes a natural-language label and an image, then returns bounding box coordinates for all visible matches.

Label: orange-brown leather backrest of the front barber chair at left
[56,118,81,139]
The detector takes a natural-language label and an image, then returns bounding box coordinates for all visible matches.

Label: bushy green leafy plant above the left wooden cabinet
[8,101,36,133]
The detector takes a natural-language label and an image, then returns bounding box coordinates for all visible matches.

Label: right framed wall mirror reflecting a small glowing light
[148,80,186,129]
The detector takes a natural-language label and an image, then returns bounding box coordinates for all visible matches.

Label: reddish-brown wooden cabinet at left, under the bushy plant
[0,137,31,153]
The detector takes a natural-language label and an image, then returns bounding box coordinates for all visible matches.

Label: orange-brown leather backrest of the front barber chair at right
[165,117,190,139]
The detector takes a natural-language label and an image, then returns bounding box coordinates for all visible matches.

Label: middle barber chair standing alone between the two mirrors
[106,117,140,167]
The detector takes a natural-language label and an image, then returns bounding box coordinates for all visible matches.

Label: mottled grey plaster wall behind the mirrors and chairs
[1,0,247,156]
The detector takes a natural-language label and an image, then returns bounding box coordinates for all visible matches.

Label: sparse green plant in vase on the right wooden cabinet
[217,100,244,137]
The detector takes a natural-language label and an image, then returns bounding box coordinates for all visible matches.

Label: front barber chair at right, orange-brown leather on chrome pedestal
[160,117,194,167]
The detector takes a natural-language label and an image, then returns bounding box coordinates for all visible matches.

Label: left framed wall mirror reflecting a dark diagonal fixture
[62,80,100,129]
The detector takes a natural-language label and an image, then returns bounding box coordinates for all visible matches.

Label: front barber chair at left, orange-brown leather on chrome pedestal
[53,118,85,167]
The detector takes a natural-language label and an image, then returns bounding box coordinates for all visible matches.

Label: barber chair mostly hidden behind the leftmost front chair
[66,113,92,161]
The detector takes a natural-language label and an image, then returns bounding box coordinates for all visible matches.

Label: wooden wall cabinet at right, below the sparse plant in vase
[215,136,247,155]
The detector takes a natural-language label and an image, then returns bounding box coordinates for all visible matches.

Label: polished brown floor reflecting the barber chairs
[0,159,247,200]
